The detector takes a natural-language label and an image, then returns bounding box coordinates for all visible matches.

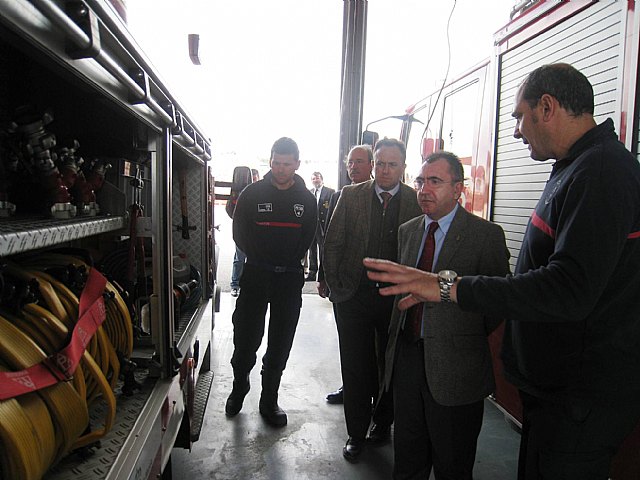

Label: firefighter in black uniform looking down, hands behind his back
[225,137,317,427]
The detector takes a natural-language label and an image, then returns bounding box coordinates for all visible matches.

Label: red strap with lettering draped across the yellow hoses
[0,268,107,400]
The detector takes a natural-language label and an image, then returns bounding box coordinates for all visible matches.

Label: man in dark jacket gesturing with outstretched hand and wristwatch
[365,64,640,480]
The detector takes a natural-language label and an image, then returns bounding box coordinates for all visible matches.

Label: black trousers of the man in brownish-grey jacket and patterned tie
[336,286,393,439]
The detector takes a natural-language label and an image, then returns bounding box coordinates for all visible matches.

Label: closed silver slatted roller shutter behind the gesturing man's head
[492,1,626,270]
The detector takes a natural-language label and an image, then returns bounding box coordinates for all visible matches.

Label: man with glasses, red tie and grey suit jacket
[384,152,509,480]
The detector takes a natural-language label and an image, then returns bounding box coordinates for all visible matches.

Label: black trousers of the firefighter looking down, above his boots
[231,264,304,373]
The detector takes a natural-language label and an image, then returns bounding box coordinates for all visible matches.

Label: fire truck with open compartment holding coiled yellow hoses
[0,0,219,479]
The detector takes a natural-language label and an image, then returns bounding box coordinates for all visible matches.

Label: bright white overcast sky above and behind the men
[127,0,514,186]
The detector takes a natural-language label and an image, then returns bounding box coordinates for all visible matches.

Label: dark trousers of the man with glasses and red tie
[393,335,484,480]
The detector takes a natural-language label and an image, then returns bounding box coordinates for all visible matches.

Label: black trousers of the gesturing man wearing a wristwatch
[518,391,640,480]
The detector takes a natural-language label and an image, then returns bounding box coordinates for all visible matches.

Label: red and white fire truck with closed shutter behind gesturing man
[363,0,640,480]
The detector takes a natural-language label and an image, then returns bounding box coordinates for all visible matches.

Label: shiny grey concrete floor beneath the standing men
[172,207,519,480]
